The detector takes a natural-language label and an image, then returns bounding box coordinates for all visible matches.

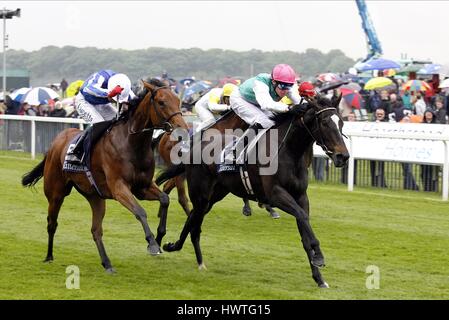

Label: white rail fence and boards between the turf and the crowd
[0,115,449,201]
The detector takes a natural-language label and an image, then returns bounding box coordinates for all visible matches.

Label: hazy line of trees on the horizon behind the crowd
[2,46,355,86]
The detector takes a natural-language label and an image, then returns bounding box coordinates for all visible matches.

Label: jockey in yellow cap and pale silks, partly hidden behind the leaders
[195,83,237,131]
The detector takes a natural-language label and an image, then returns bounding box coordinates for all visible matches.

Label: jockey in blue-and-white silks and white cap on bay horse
[69,70,135,157]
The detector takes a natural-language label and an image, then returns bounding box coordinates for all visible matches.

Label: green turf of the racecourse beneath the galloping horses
[0,152,449,299]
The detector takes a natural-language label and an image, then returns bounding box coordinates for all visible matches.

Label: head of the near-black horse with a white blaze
[301,95,349,167]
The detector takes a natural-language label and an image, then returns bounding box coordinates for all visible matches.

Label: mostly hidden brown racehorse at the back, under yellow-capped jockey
[152,111,279,217]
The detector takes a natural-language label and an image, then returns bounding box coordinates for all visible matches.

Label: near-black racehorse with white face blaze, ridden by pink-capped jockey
[156,96,349,287]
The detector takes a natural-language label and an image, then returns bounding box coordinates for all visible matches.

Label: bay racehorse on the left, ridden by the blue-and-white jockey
[22,79,187,273]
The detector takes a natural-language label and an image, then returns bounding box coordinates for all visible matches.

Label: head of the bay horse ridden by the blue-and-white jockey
[133,79,188,132]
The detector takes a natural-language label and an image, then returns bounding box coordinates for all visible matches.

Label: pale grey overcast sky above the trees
[0,0,449,64]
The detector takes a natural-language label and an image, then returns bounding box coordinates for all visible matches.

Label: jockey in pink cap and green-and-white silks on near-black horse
[225,64,308,161]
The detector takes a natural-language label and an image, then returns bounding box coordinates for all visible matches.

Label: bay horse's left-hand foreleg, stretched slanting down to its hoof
[108,180,161,255]
